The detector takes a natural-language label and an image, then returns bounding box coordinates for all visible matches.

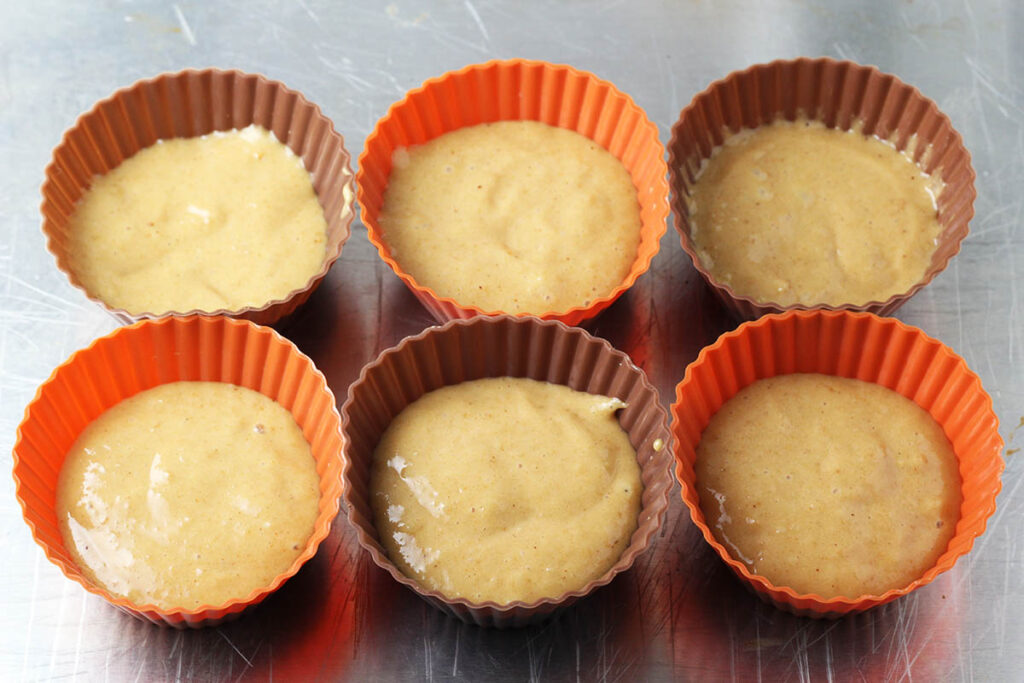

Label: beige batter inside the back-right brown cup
[690,120,941,305]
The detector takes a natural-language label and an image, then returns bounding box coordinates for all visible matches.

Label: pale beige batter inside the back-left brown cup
[69,126,327,313]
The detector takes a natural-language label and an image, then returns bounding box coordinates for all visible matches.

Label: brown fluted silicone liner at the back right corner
[669,57,976,319]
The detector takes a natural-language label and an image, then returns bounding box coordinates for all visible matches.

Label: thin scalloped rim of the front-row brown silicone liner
[341,313,674,626]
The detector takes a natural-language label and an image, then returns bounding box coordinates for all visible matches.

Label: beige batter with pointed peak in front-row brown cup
[370,378,643,604]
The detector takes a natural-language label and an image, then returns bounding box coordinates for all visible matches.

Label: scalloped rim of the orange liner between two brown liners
[355,57,672,322]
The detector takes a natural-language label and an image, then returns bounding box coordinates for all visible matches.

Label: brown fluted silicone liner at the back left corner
[41,69,354,325]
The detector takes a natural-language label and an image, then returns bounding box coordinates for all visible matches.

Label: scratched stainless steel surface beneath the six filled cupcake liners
[0,0,1024,680]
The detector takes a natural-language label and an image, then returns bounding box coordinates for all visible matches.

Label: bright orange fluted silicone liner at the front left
[14,316,342,628]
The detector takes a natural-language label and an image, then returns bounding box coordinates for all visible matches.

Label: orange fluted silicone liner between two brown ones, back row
[356,59,669,325]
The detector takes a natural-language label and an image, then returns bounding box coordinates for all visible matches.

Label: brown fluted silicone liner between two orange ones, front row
[341,315,673,628]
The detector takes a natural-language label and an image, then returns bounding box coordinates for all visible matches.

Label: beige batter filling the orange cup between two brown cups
[380,121,640,313]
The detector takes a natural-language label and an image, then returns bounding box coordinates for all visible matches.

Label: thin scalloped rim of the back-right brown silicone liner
[667,56,978,316]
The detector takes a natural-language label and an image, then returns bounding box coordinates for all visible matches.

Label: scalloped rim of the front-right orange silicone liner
[671,309,1006,616]
